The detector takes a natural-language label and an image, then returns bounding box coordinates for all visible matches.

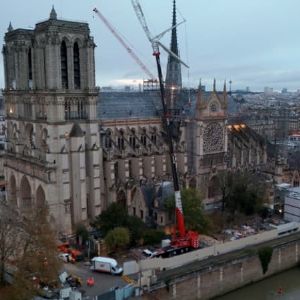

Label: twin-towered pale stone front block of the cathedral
[2,8,101,233]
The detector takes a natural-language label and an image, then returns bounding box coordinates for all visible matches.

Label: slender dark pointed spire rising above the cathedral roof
[166,0,182,89]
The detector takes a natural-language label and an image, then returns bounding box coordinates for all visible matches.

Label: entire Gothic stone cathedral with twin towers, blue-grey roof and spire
[2,1,266,234]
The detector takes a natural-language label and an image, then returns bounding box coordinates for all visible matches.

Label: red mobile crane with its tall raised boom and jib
[131,0,199,257]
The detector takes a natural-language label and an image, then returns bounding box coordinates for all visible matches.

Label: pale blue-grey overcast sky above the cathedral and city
[0,0,300,90]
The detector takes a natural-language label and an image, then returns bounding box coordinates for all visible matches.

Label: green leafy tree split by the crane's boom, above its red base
[165,188,209,232]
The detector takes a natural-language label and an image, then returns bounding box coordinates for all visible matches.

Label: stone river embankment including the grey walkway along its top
[144,233,300,300]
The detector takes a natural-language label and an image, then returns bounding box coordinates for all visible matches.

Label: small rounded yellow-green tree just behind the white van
[105,227,130,251]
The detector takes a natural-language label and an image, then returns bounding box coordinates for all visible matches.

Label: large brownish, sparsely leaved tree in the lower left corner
[0,203,61,300]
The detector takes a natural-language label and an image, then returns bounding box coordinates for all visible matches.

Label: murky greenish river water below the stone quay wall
[217,268,300,300]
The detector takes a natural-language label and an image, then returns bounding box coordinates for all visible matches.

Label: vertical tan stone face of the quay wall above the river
[142,241,300,300]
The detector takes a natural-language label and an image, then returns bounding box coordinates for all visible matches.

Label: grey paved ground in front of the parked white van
[63,262,128,297]
